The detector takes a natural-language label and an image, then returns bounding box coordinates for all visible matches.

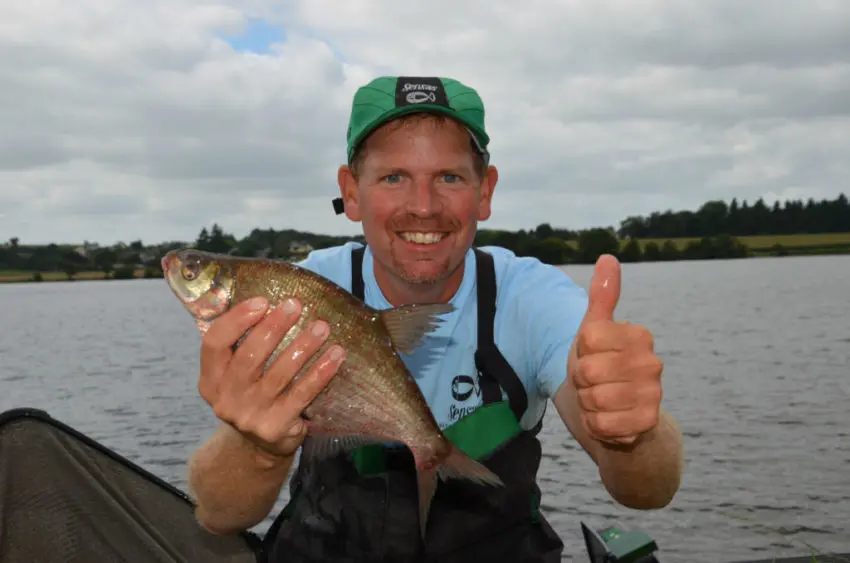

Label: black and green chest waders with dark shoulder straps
[265,248,564,563]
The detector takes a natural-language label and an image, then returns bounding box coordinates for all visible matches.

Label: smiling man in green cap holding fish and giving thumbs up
[190,77,682,562]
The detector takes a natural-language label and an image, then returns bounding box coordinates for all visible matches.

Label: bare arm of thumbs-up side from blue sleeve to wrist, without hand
[553,374,684,509]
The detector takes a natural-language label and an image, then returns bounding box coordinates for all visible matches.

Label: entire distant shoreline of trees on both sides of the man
[0,194,850,279]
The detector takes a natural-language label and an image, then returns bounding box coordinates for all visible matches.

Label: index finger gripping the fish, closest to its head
[198,298,268,402]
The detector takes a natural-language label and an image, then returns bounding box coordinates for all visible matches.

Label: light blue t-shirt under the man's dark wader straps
[298,242,588,429]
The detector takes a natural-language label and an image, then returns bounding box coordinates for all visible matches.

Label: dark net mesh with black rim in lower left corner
[0,410,261,563]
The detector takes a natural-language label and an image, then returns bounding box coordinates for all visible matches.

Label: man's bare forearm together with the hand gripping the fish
[189,294,345,534]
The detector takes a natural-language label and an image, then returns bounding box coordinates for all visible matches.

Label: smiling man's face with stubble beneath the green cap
[340,115,498,290]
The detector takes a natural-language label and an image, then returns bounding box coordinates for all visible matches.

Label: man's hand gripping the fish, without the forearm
[198,298,344,457]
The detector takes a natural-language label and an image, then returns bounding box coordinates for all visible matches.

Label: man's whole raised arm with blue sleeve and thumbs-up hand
[510,261,684,509]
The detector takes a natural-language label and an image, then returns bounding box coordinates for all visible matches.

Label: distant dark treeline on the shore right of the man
[476,193,850,264]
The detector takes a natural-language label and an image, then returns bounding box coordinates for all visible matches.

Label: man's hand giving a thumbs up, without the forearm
[568,255,663,445]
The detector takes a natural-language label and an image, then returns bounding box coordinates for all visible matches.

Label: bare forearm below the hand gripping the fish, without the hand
[189,424,293,534]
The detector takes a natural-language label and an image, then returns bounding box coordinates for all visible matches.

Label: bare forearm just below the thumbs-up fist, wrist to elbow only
[596,409,684,509]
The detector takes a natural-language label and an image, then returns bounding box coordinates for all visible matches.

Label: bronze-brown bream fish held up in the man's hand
[162,249,503,536]
